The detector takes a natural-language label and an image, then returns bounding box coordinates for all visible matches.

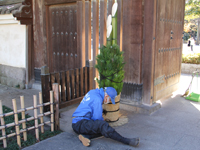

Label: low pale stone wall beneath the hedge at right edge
[181,63,200,74]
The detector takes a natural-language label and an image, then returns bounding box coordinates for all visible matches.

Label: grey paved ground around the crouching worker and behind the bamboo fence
[0,74,200,150]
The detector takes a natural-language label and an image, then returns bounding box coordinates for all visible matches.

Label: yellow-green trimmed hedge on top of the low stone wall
[182,53,200,64]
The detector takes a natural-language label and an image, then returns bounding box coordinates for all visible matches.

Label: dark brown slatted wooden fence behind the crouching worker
[41,67,94,112]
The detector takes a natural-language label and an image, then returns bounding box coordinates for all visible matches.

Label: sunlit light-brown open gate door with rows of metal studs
[153,0,185,101]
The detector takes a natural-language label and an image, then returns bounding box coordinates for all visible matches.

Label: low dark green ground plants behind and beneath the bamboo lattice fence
[0,106,61,150]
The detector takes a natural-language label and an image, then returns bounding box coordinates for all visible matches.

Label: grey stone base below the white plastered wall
[0,64,26,89]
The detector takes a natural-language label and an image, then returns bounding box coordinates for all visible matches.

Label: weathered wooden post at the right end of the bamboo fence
[52,83,60,130]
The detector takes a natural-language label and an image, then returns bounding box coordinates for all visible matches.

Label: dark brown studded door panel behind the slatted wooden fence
[48,3,80,72]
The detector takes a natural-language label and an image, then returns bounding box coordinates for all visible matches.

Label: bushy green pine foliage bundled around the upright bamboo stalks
[95,44,125,94]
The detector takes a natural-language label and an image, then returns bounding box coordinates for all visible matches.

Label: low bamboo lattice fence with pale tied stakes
[0,91,58,148]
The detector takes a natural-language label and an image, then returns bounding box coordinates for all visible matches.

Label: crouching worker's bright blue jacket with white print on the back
[72,88,104,123]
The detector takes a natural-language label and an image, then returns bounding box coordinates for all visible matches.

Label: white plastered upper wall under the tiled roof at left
[0,14,26,68]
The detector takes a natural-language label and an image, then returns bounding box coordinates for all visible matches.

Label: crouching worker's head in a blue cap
[103,87,117,104]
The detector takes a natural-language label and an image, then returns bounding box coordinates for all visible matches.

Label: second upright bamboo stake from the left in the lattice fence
[12,99,21,147]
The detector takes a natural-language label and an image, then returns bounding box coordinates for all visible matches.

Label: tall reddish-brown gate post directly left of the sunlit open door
[142,0,156,105]
